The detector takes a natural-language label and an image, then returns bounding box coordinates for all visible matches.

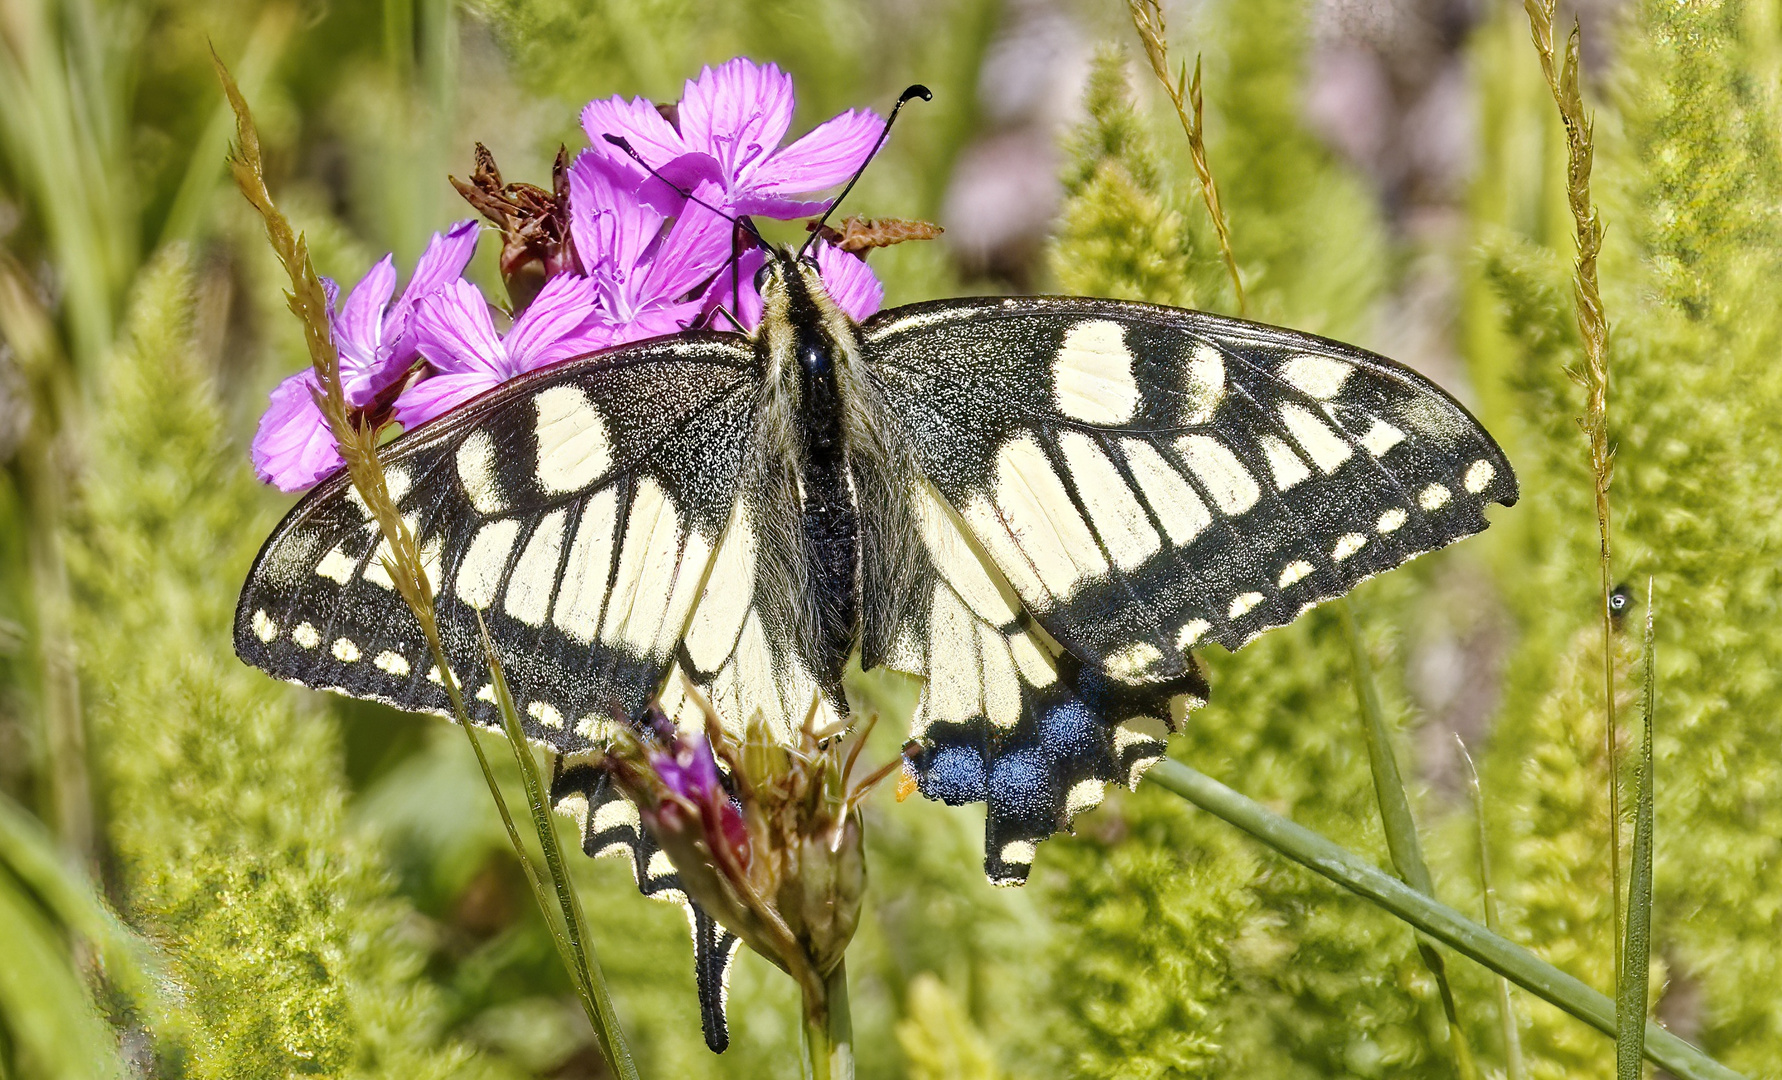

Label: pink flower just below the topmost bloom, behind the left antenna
[568,153,731,346]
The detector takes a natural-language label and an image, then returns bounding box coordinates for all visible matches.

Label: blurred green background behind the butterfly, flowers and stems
[0,0,1782,1080]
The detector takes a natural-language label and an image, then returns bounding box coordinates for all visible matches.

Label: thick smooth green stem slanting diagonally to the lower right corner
[1146,757,1741,1080]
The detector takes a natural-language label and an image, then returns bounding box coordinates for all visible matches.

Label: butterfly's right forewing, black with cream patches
[862,298,1516,684]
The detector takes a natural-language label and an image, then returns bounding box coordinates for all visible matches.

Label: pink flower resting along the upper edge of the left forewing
[396,274,611,430]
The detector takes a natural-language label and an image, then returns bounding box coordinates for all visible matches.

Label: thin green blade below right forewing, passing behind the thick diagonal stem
[1333,599,1479,1080]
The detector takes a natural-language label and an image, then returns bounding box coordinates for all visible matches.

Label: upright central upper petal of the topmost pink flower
[681,57,793,191]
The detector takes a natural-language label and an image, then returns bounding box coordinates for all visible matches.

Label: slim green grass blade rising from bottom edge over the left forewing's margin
[478,617,638,1080]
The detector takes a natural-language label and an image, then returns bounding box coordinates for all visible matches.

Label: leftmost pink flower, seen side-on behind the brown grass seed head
[249,221,476,492]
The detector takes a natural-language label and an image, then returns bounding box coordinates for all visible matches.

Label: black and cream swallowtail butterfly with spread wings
[235,250,1516,1048]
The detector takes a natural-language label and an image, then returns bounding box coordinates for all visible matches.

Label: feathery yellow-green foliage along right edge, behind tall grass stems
[1479,2,1782,1076]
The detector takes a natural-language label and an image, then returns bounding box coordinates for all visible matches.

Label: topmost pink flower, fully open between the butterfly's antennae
[581,57,884,219]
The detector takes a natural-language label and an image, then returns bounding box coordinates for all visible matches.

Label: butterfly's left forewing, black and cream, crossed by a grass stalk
[235,335,754,752]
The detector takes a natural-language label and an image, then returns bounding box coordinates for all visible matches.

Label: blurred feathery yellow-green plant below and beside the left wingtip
[71,251,502,1076]
